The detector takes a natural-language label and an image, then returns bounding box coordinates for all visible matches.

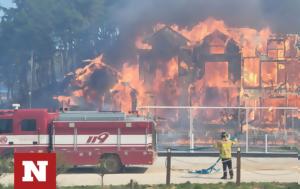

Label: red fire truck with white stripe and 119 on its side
[0,109,156,173]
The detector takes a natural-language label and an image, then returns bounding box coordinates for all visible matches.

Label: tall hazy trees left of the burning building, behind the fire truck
[0,0,118,105]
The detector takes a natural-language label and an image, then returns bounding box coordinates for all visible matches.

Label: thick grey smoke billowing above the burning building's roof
[107,0,300,60]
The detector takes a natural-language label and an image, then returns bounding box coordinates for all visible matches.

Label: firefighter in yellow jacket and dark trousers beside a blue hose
[215,132,236,179]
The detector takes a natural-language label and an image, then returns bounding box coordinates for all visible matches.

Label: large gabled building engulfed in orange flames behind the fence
[58,18,300,148]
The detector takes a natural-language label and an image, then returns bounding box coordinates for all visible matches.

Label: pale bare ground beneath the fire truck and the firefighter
[0,157,300,186]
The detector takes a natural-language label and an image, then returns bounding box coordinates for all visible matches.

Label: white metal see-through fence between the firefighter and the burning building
[138,106,300,153]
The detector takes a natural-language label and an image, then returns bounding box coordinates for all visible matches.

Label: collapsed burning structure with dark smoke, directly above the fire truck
[55,55,119,108]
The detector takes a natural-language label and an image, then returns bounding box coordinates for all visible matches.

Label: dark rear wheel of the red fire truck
[101,154,122,173]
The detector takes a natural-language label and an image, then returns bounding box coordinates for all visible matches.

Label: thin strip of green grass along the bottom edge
[0,182,300,189]
